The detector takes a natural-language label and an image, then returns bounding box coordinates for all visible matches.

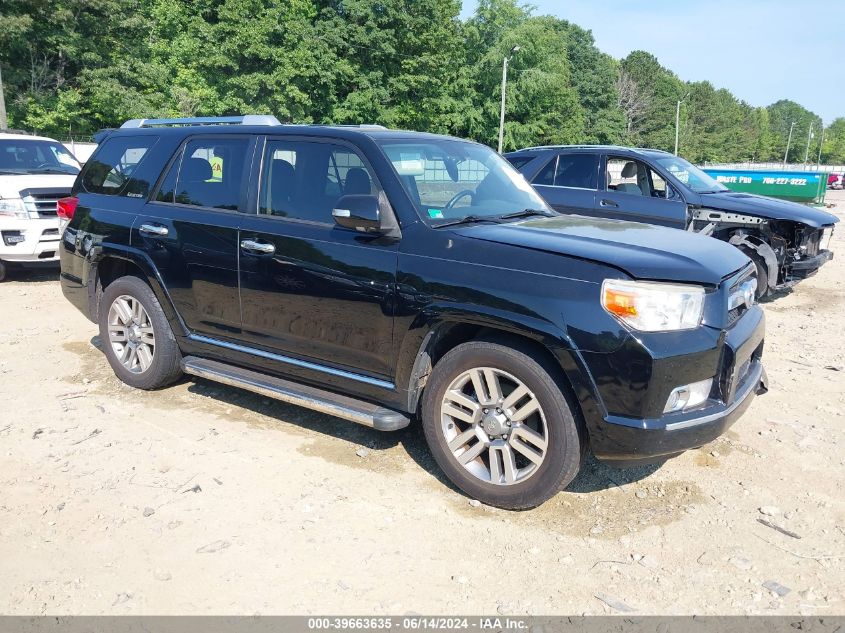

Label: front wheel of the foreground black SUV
[422,341,586,510]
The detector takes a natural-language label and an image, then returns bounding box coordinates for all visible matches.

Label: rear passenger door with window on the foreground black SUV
[132,134,255,338]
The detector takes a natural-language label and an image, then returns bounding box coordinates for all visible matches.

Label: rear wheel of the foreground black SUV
[97,277,182,389]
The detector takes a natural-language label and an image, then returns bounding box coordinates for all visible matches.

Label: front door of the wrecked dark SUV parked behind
[595,155,687,229]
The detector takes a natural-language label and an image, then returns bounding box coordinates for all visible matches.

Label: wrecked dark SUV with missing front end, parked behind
[506,145,839,298]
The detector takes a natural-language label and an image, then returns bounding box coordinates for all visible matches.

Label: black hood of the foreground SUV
[454,215,749,285]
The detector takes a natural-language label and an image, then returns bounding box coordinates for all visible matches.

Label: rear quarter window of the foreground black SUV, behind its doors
[82,136,158,197]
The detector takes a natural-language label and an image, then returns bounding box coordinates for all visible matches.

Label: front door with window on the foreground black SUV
[239,137,398,377]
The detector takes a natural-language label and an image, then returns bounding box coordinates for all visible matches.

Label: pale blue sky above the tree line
[461,0,845,124]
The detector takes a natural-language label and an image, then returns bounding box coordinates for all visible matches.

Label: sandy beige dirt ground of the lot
[0,192,845,615]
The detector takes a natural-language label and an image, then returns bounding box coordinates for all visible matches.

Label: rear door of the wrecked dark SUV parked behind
[531,153,599,215]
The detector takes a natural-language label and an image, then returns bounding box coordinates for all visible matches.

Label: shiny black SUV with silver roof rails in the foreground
[60,116,765,508]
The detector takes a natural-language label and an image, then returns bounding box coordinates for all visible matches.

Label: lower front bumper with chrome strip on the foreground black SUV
[590,304,768,466]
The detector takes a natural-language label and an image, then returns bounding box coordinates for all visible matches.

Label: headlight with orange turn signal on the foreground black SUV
[601,279,704,332]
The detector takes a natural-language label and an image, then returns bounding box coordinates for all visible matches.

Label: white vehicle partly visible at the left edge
[0,133,79,281]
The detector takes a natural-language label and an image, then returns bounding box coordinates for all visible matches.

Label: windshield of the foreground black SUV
[379,139,552,226]
